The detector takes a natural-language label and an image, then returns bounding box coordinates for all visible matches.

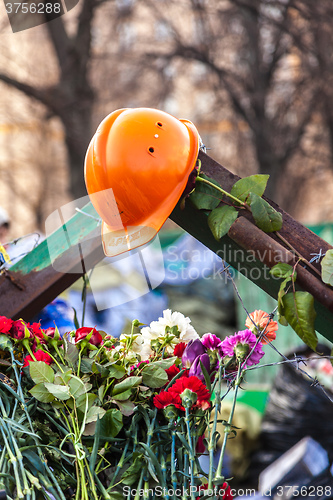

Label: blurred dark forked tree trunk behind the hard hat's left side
[0,0,99,198]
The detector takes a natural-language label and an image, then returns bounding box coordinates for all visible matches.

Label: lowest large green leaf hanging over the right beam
[282,292,318,351]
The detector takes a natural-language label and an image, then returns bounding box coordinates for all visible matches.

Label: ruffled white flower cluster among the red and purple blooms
[140,309,199,361]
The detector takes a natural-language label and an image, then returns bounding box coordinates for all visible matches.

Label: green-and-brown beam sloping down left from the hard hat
[0,204,104,321]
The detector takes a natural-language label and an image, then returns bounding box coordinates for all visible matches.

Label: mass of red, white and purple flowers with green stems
[0,310,276,500]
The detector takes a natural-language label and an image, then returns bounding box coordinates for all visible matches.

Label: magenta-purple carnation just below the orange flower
[221,330,265,366]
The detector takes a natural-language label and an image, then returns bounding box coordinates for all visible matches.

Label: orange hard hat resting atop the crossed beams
[85,108,199,256]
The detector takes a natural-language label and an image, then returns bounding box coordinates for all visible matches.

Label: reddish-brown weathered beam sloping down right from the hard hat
[170,152,333,342]
